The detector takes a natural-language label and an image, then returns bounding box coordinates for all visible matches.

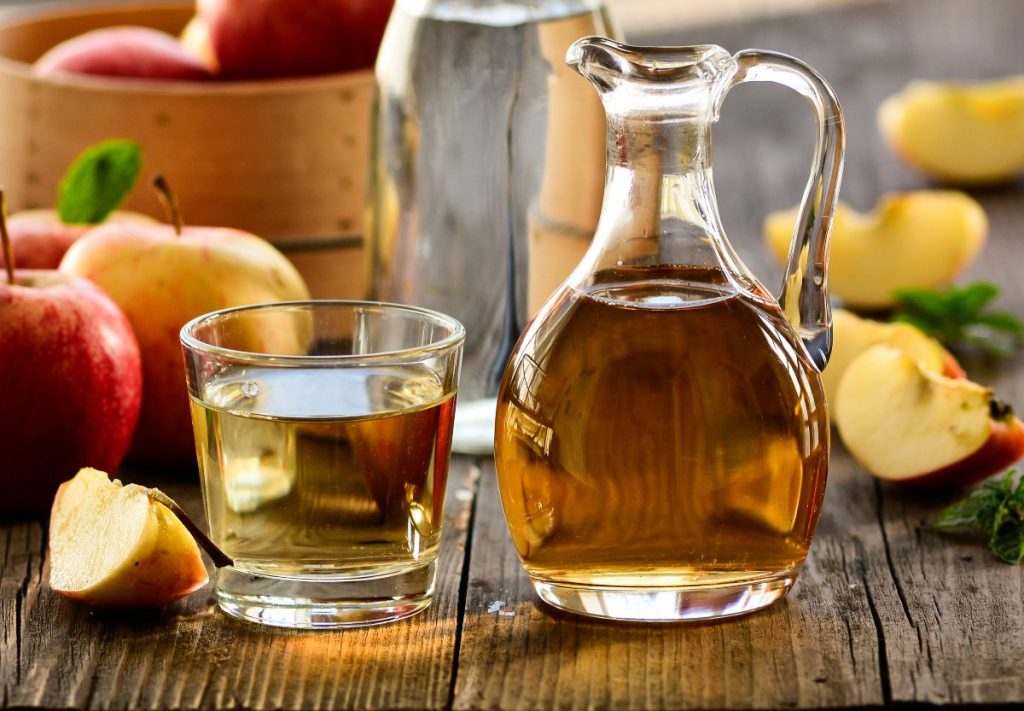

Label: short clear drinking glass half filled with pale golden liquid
[181,301,465,628]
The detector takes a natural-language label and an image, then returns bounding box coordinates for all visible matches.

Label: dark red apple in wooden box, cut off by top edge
[197,0,393,79]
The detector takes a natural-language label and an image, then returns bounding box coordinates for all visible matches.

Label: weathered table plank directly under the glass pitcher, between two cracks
[455,458,898,709]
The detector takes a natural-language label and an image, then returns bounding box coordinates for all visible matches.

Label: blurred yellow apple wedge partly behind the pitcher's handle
[764,191,988,308]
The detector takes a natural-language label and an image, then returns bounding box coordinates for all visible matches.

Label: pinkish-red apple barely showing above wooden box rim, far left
[33,27,210,81]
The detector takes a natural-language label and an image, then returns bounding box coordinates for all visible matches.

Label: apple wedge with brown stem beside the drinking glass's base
[49,468,231,608]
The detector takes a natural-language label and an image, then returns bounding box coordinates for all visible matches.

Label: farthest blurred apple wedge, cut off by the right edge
[879,77,1024,184]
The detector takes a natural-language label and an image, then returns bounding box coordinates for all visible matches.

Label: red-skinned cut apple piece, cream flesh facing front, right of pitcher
[836,345,1024,487]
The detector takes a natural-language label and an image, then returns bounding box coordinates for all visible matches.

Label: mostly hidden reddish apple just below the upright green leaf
[0,210,156,269]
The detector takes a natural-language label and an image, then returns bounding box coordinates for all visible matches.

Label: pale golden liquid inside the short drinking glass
[191,369,454,576]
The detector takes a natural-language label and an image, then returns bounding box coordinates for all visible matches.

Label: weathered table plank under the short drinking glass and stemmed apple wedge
[0,459,478,709]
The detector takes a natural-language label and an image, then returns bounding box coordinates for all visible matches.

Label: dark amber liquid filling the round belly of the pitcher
[496,266,828,588]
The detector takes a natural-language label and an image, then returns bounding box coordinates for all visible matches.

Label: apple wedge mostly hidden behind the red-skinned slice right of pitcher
[821,308,965,417]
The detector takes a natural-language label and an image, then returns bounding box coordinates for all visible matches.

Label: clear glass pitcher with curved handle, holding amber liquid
[495,37,844,621]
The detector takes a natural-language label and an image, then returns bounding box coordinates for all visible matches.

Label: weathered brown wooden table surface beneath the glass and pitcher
[0,0,1024,709]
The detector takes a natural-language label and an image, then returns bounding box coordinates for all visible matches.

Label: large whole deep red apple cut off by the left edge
[0,269,142,515]
